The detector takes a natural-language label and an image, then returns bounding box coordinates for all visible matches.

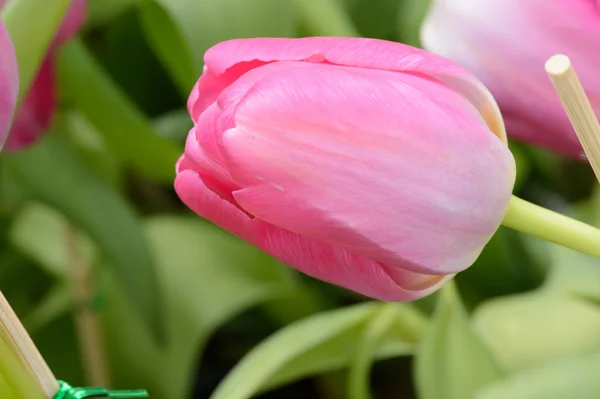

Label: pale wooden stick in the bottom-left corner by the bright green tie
[0,292,59,398]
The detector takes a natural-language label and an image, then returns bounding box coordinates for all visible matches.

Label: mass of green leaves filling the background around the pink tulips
[0,0,600,399]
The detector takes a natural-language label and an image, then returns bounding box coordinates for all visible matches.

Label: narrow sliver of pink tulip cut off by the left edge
[0,20,19,150]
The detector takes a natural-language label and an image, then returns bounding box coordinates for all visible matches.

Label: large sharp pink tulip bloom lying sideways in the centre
[175,38,515,301]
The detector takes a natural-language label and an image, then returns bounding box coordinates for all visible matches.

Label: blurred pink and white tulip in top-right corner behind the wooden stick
[422,0,600,156]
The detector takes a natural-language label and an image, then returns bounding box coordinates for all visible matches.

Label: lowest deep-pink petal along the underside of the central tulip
[175,167,451,301]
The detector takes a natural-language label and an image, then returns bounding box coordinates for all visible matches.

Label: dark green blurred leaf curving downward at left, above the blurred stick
[5,134,164,338]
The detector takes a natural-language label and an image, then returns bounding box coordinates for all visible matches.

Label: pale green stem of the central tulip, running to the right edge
[502,196,600,258]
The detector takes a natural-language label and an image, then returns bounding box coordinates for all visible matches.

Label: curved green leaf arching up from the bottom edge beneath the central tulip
[211,303,425,399]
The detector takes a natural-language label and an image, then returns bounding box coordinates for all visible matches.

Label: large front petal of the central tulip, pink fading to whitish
[222,64,515,274]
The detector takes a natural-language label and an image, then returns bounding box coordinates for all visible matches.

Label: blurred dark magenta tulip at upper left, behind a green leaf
[0,0,86,151]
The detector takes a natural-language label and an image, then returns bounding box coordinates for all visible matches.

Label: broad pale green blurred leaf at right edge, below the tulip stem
[473,292,600,370]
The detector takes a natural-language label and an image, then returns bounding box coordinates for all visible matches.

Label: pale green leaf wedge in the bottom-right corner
[475,352,600,399]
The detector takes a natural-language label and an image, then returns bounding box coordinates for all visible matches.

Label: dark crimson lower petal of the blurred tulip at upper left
[6,58,56,151]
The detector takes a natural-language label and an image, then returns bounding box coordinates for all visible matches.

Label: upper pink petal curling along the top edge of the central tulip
[197,37,505,140]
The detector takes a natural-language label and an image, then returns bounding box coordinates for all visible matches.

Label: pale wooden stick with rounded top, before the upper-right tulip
[546,54,600,181]
